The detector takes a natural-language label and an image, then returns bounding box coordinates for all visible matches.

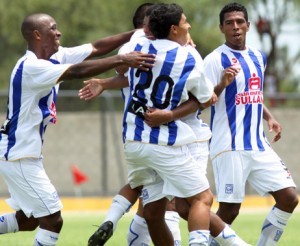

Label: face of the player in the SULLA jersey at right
[220,11,250,50]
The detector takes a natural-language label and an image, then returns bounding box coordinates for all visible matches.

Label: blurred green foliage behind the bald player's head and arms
[0,0,138,89]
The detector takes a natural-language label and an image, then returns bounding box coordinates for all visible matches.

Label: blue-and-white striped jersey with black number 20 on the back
[123,40,213,146]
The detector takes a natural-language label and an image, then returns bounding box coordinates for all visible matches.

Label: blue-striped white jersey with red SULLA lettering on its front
[204,44,269,158]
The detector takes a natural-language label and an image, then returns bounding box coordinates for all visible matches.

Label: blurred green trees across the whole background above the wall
[0,0,300,93]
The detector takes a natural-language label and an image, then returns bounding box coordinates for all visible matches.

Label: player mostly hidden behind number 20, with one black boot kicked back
[80,3,181,245]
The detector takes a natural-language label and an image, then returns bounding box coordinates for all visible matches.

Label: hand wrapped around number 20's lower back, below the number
[144,107,173,127]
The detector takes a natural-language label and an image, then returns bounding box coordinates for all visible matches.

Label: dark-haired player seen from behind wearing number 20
[123,4,213,246]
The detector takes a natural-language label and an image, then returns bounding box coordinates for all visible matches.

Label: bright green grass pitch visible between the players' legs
[0,210,300,246]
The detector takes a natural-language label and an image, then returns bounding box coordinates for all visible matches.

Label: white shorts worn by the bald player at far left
[0,158,63,218]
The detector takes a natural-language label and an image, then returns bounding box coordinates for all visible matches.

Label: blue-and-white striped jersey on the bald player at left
[0,44,92,161]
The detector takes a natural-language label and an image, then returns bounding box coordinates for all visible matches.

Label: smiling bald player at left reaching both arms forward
[0,13,155,246]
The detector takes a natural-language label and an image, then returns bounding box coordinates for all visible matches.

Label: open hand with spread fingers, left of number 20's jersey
[78,78,105,101]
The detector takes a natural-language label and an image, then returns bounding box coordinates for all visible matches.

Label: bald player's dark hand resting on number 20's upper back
[120,51,155,71]
